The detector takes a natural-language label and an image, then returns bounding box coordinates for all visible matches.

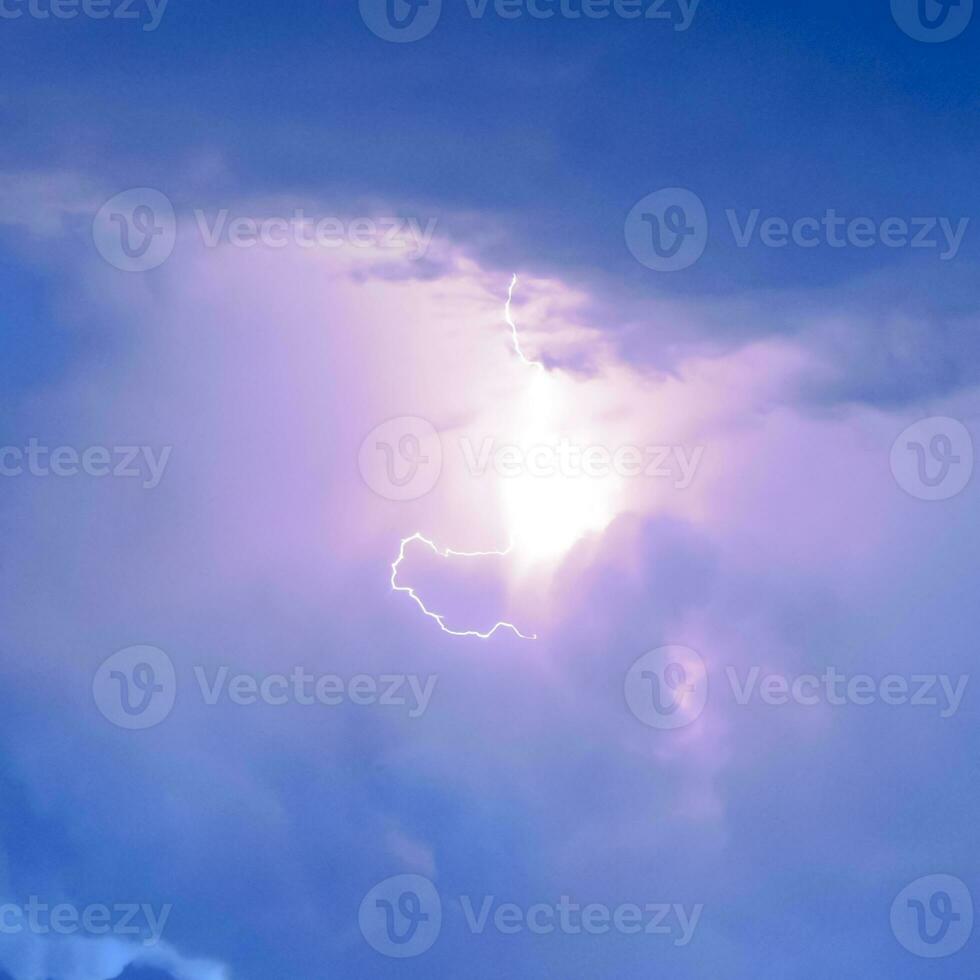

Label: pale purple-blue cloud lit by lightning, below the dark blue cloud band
[0,174,977,980]
